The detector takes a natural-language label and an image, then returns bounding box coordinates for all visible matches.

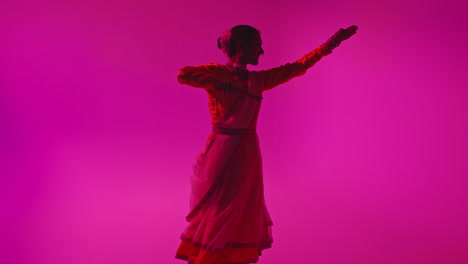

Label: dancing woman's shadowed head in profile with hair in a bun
[218,25,264,65]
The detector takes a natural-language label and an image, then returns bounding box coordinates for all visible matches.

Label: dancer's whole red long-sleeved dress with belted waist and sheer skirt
[176,45,331,264]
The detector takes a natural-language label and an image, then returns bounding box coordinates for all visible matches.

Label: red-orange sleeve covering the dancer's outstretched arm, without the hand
[258,44,331,91]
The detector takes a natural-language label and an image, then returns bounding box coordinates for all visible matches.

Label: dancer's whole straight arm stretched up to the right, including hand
[258,26,357,91]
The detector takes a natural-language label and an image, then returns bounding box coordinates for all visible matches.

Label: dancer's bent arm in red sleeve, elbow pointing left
[177,63,222,90]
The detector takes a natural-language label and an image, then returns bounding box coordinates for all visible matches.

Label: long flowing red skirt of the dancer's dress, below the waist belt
[176,132,273,264]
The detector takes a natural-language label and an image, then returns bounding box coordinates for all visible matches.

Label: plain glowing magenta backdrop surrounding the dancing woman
[0,0,468,264]
